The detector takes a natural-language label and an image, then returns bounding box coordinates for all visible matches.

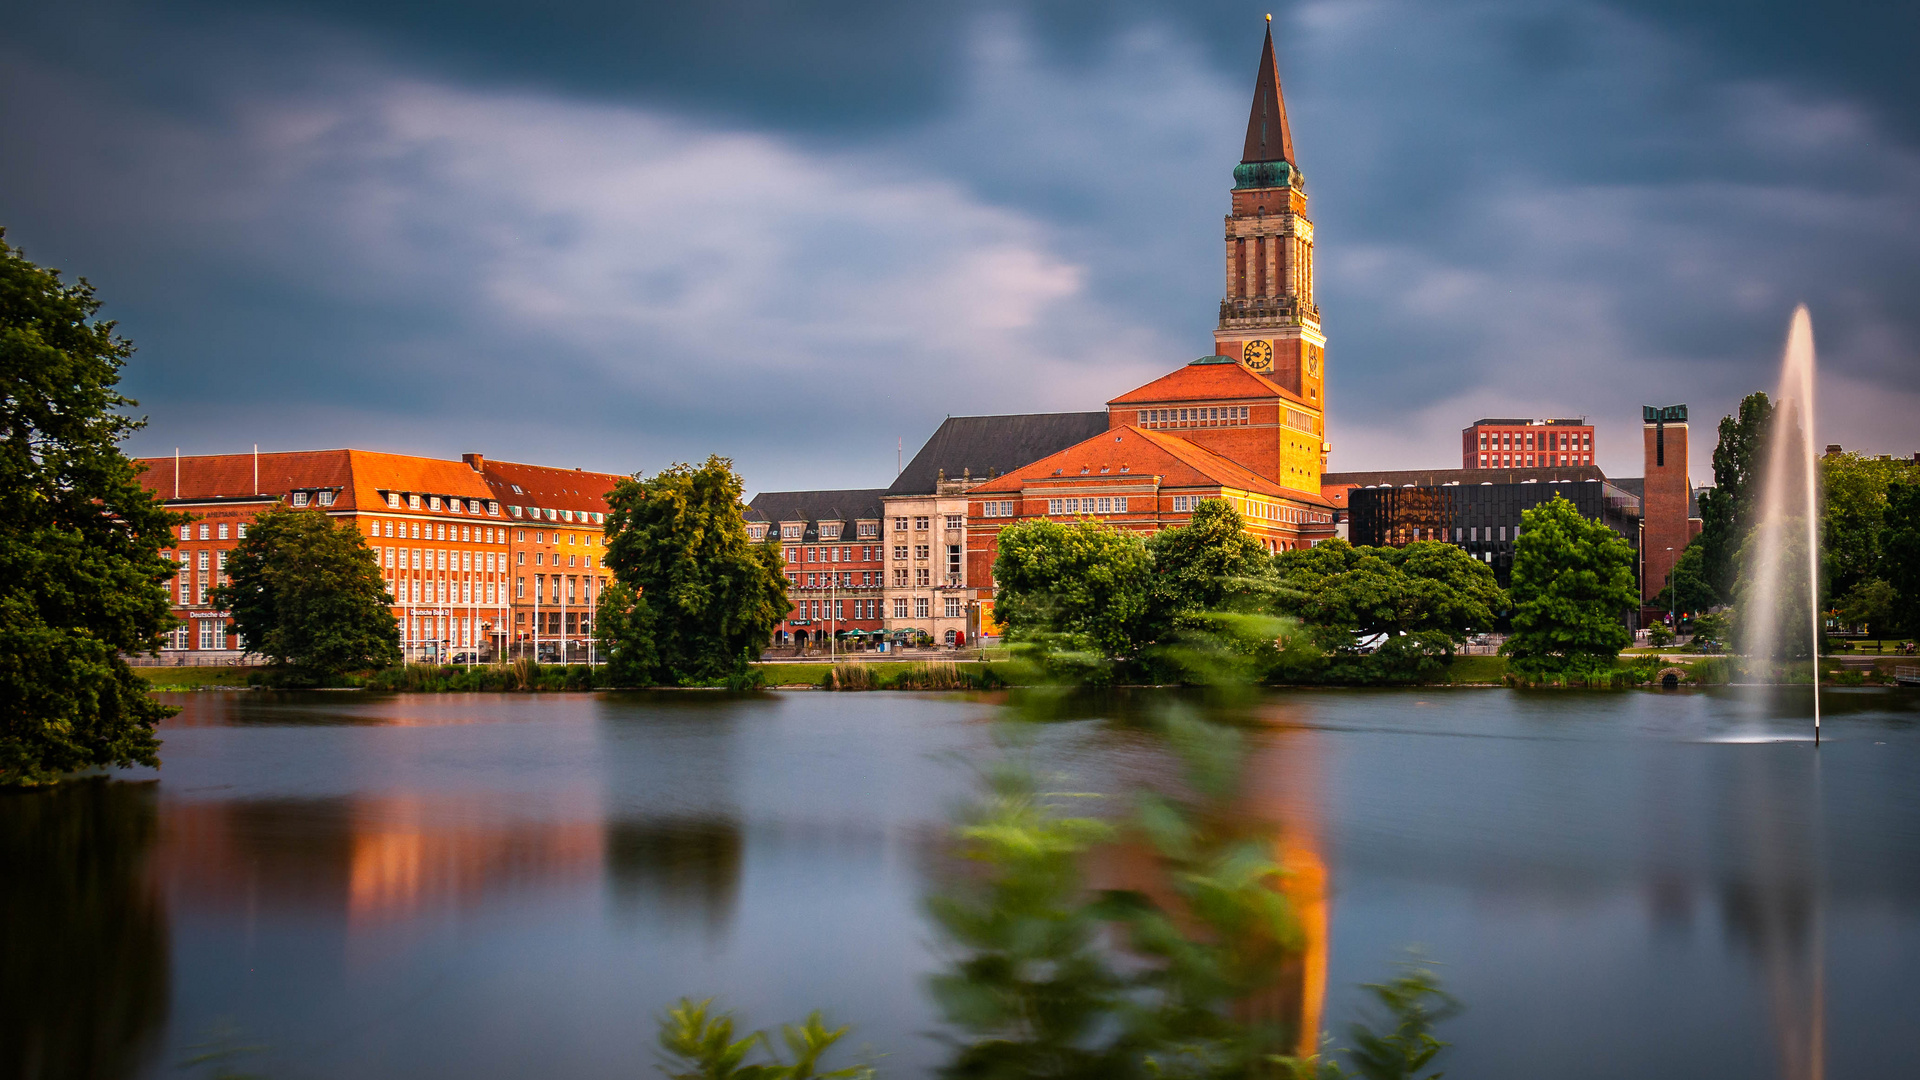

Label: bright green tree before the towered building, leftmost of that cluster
[993,519,1152,659]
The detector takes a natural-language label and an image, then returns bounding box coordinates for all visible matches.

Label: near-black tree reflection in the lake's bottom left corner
[0,782,169,1080]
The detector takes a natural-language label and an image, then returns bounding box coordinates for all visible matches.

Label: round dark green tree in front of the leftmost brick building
[211,507,399,686]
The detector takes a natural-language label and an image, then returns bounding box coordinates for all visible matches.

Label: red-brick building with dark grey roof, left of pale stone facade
[745,488,887,650]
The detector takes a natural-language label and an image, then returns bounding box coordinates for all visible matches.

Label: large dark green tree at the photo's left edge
[0,233,184,786]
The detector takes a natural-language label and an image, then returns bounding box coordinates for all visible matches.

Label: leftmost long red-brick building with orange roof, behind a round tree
[140,450,509,659]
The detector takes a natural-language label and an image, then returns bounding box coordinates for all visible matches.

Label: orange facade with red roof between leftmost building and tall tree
[478,454,626,663]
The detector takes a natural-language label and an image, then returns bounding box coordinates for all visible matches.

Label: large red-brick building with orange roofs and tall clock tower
[966,31,1334,626]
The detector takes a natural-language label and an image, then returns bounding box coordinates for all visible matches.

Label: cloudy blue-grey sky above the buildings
[0,0,1920,492]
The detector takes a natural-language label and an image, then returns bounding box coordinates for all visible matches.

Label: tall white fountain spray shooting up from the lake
[1741,304,1820,734]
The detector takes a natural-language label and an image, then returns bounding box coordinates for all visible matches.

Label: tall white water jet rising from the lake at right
[1740,304,1820,730]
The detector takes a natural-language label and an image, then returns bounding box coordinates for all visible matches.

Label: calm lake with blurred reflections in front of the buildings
[0,688,1920,1080]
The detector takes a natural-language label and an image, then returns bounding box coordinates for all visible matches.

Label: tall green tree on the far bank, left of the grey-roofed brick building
[599,457,789,686]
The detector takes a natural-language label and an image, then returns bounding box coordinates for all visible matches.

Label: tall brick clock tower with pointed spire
[1213,15,1327,424]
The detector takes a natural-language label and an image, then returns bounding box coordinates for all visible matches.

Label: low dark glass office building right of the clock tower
[1348,480,1640,586]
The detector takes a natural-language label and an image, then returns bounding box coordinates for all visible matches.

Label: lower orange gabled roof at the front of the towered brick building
[973,425,1327,505]
